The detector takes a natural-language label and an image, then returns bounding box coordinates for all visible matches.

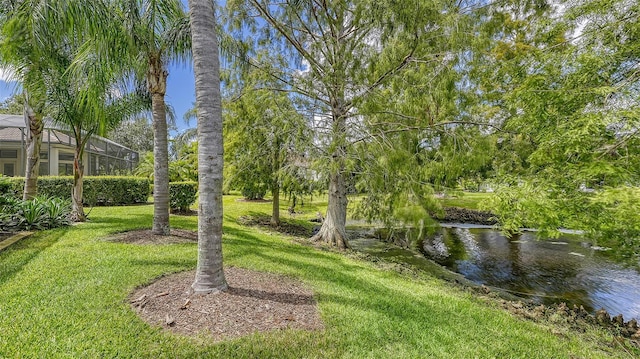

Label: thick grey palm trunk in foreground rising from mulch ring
[189,0,227,293]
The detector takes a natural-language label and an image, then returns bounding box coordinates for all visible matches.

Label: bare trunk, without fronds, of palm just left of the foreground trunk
[147,63,170,235]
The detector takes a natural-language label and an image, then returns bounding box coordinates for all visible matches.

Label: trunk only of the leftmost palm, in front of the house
[22,104,44,200]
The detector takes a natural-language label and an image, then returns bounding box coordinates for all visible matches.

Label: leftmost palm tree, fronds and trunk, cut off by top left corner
[0,0,115,199]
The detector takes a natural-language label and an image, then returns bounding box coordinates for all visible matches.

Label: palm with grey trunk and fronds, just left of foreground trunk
[116,0,191,235]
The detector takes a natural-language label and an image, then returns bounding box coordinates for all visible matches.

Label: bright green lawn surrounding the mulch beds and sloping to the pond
[0,196,629,358]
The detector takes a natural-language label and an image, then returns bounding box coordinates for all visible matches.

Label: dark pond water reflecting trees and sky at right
[423,228,640,320]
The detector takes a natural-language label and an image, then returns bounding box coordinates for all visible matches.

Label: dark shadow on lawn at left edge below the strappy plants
[0,228,68,285]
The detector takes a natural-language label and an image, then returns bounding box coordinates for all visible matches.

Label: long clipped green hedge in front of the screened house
[5,176,150,206]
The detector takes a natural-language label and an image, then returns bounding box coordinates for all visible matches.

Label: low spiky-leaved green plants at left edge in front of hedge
[0,194,71,232]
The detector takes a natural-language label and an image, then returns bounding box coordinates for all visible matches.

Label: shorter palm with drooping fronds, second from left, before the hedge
[45,34,149,222]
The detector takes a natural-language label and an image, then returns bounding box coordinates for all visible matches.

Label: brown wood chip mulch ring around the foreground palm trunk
[129,267,323,342]
